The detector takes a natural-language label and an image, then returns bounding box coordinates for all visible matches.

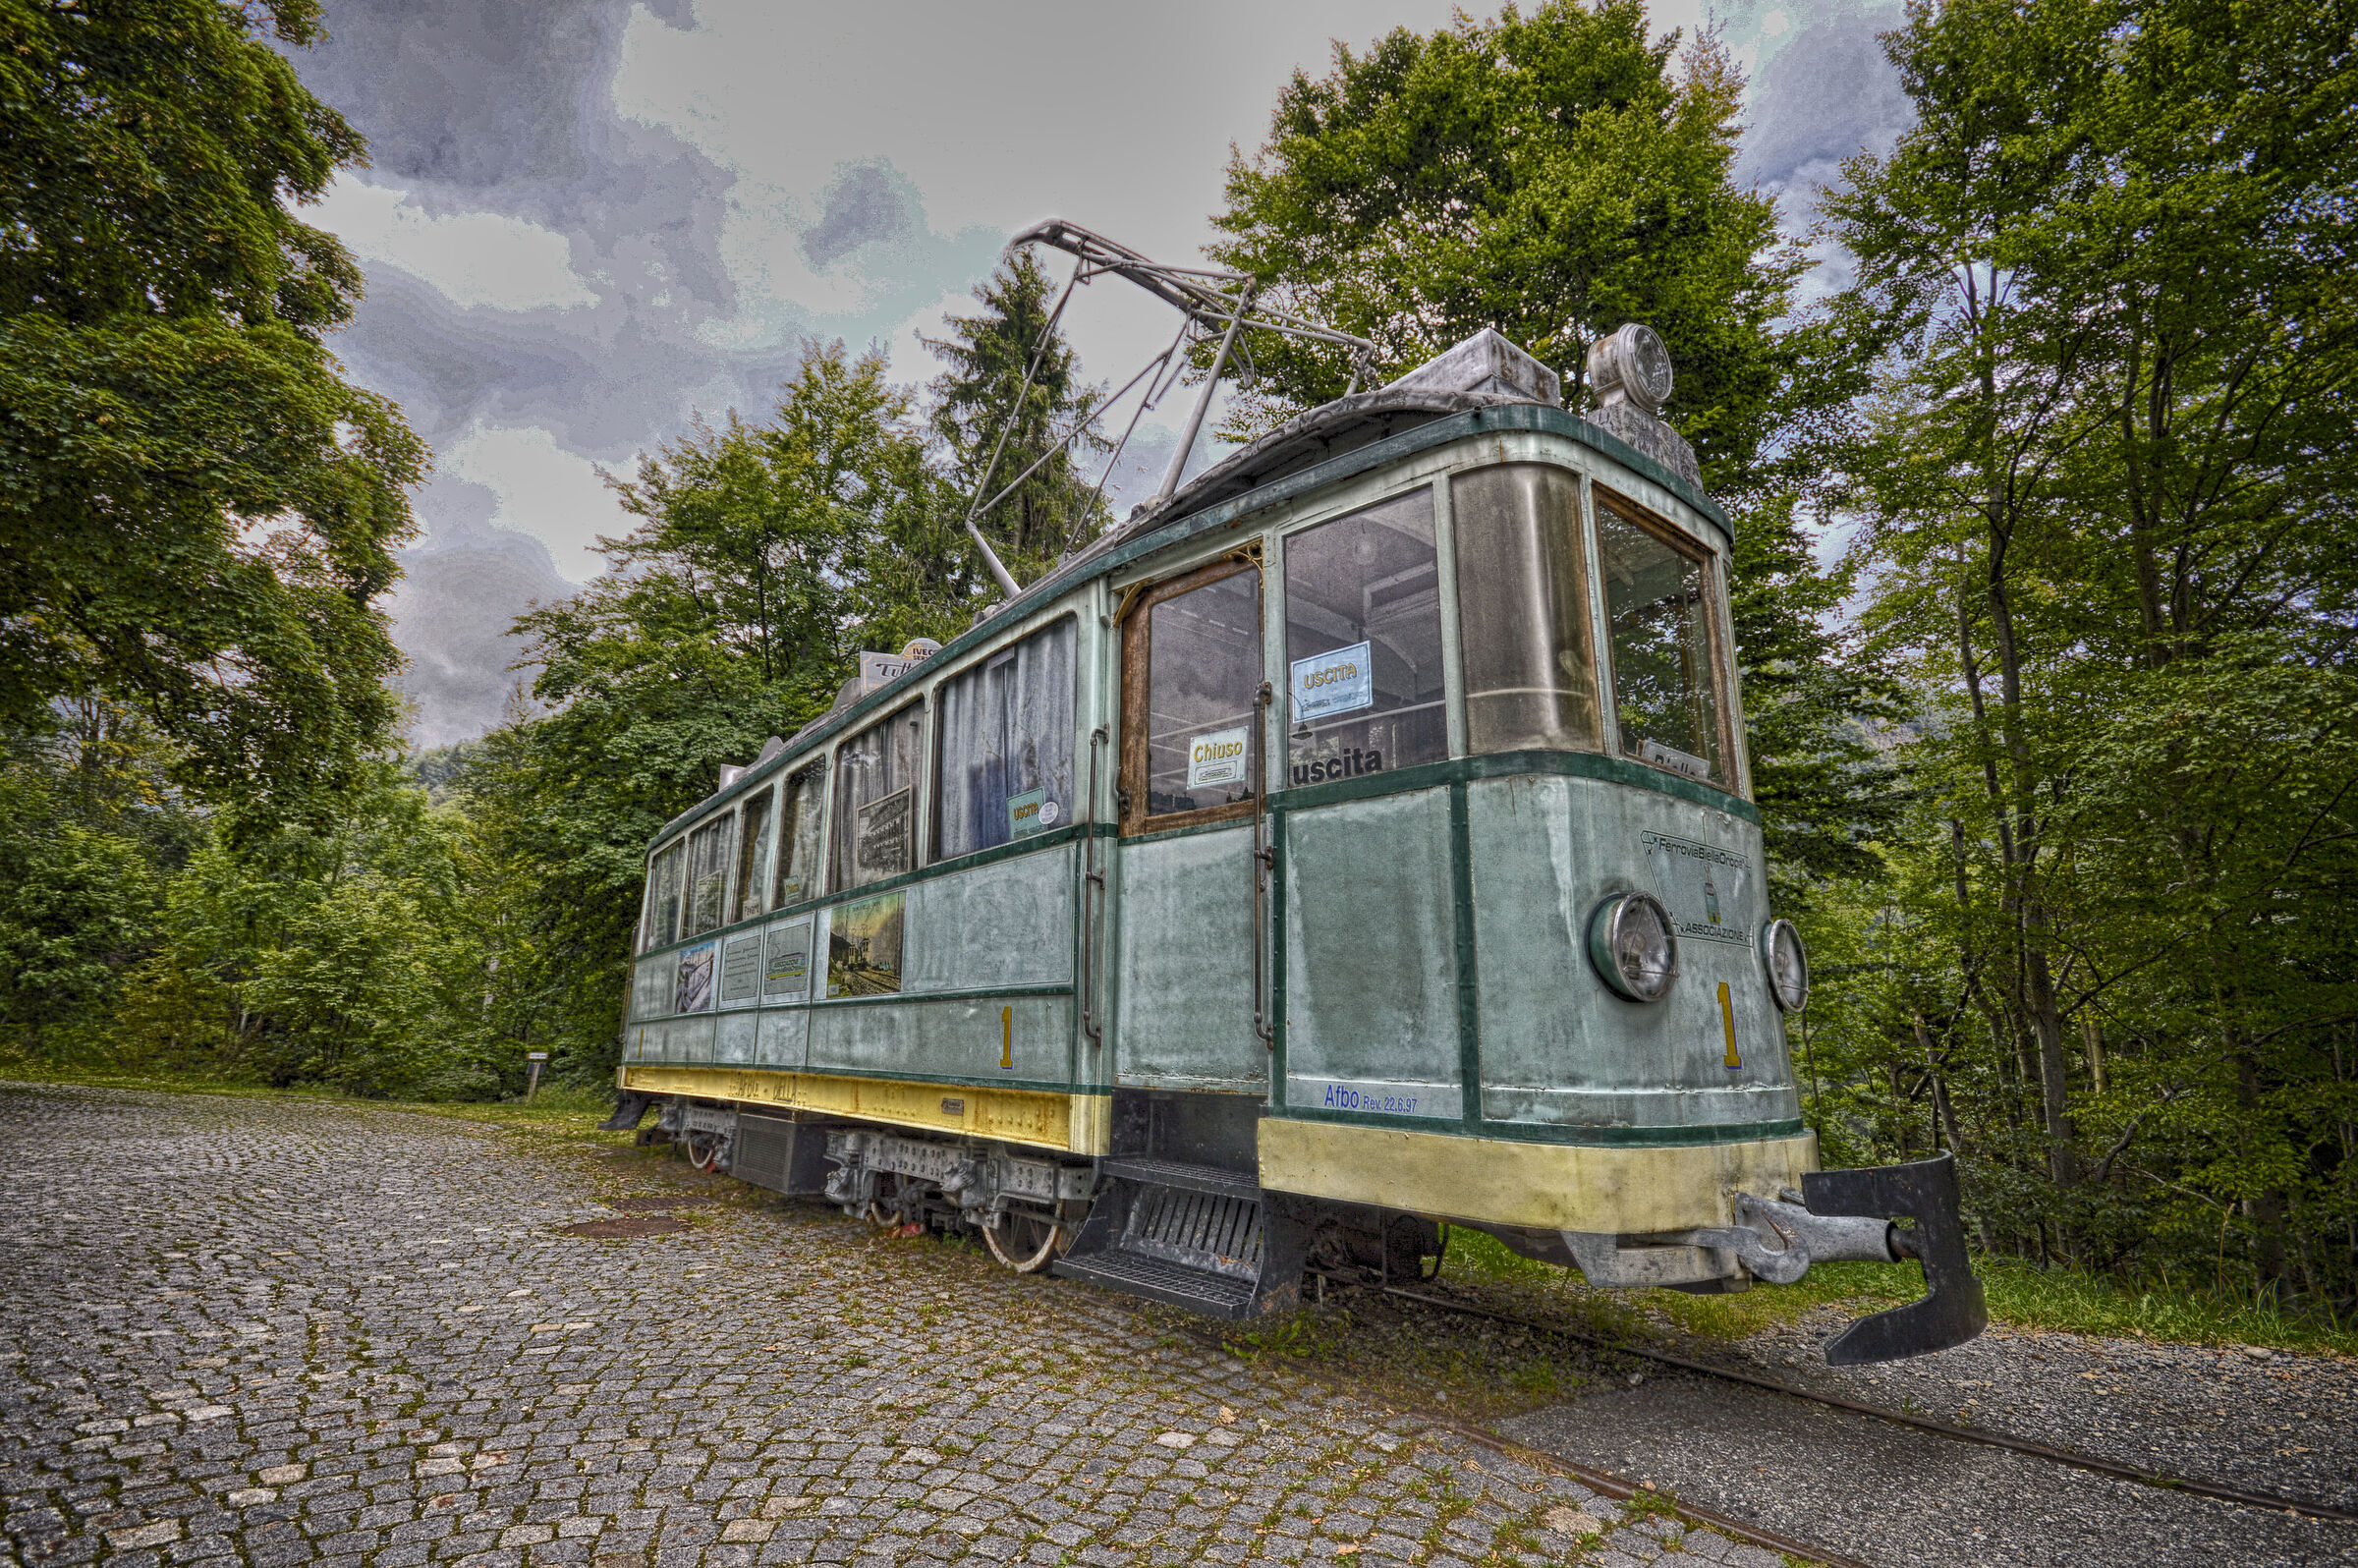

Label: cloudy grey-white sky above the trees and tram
[295,0,1908,745]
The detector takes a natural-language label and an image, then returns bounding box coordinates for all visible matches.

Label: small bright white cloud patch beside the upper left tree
[305,175,599,311]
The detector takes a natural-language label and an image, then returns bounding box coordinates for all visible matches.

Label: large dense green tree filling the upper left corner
[0,0,422,815]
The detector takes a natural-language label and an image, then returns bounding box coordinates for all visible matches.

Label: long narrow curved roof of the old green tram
[648,398,1735,844]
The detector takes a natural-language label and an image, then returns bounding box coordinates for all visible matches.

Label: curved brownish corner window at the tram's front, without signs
[1450,462,1601,753]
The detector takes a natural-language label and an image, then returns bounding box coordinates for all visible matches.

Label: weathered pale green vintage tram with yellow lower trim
[608,278,1983,1361]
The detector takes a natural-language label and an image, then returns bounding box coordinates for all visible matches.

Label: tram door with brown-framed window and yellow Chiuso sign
[1115,559,1268,1094]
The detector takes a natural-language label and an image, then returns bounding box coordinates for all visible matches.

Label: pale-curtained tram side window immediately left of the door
[933,618,1080,859]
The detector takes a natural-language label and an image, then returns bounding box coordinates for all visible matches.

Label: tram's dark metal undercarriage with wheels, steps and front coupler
[606,1092,1983,1366]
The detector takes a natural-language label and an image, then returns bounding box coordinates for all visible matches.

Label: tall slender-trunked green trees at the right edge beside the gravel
[1827,0,2358,1299]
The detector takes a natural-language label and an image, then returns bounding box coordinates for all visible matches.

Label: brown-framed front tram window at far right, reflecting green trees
[1597,490,1726,783]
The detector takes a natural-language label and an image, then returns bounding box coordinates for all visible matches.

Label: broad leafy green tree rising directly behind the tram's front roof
[1212,0,1802,488]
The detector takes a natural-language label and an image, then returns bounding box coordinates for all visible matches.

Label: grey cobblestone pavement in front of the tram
[0,1087,1780,1568]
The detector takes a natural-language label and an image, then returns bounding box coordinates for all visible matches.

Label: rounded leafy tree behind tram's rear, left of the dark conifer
[460,344,938,1073]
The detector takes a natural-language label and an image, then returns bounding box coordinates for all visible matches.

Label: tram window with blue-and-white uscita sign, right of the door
[1285,488,1450,785]
